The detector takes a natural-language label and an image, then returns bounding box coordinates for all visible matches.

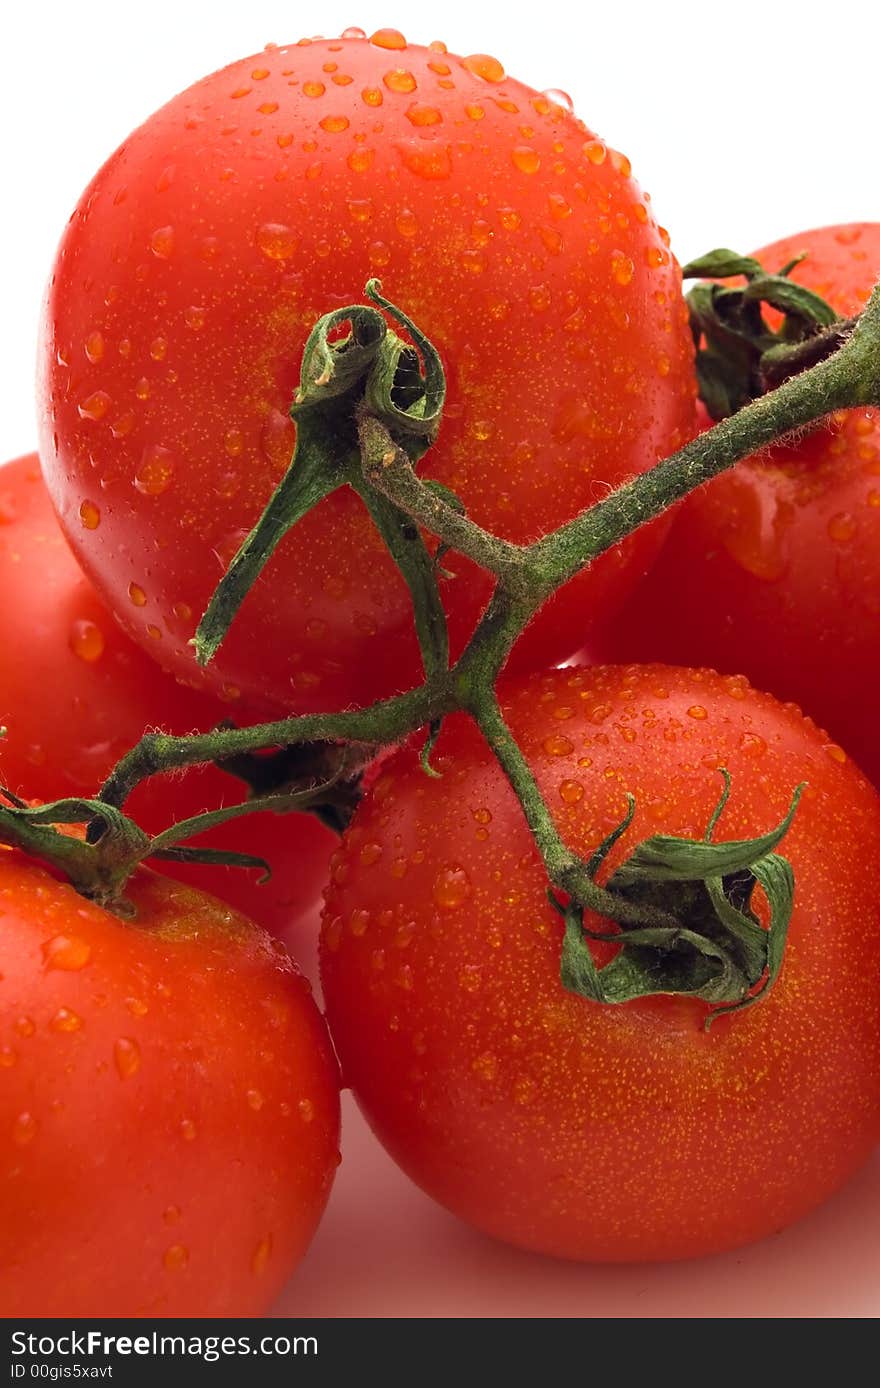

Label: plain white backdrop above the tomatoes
[0,0,880,457]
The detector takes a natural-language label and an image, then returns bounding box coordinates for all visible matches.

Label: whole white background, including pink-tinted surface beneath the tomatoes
[0,0,880,1317]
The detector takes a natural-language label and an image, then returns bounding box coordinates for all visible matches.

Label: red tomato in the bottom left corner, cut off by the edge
[0,851,339,1317]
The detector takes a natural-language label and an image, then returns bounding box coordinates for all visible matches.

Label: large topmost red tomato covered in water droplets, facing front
[40,31,694,711]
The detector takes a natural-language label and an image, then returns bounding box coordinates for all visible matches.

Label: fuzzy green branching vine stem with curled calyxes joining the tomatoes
[6,267,880,1010]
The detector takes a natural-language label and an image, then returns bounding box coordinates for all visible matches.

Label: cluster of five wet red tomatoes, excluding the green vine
[0,29,880,1316]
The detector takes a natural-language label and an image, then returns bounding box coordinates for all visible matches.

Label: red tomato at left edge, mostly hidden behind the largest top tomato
[0,454,333,933]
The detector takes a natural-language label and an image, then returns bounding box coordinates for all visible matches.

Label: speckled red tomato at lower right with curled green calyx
[322,666,880,1260]
